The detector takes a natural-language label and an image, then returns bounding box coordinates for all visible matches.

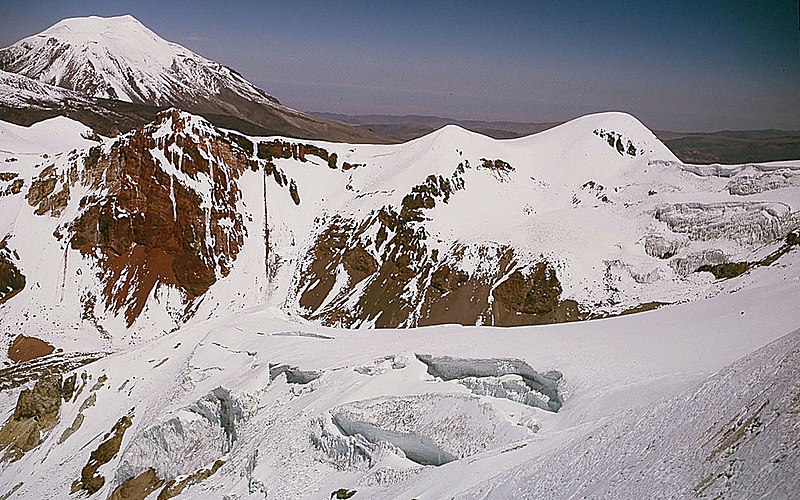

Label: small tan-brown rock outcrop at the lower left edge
[0,375,62,461]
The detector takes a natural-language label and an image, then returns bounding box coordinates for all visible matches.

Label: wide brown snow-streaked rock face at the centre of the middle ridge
[298,159,586,328]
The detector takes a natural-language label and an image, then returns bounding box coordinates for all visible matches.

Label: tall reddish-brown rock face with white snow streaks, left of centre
[28,110,249,325]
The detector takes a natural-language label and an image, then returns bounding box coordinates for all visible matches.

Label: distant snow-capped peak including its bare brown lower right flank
[0,15,382,142]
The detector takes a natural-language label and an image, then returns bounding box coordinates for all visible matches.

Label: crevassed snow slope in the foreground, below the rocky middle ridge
[0,244,800,498]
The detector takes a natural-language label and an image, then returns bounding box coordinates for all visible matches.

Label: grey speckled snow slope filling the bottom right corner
[459,330,800,498]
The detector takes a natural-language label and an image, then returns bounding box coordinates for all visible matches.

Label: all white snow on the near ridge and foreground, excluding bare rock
[0,113,800,499]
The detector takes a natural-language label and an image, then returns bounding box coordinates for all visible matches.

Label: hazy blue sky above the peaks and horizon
[0,0,800,130]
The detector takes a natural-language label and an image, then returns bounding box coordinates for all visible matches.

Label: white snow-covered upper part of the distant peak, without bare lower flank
[0,15,278,106]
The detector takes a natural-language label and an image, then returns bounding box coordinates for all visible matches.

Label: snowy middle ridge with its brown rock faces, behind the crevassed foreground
[0,110,800,348]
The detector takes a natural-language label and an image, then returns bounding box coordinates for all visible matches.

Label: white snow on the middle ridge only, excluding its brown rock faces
[0,113,800,349]
